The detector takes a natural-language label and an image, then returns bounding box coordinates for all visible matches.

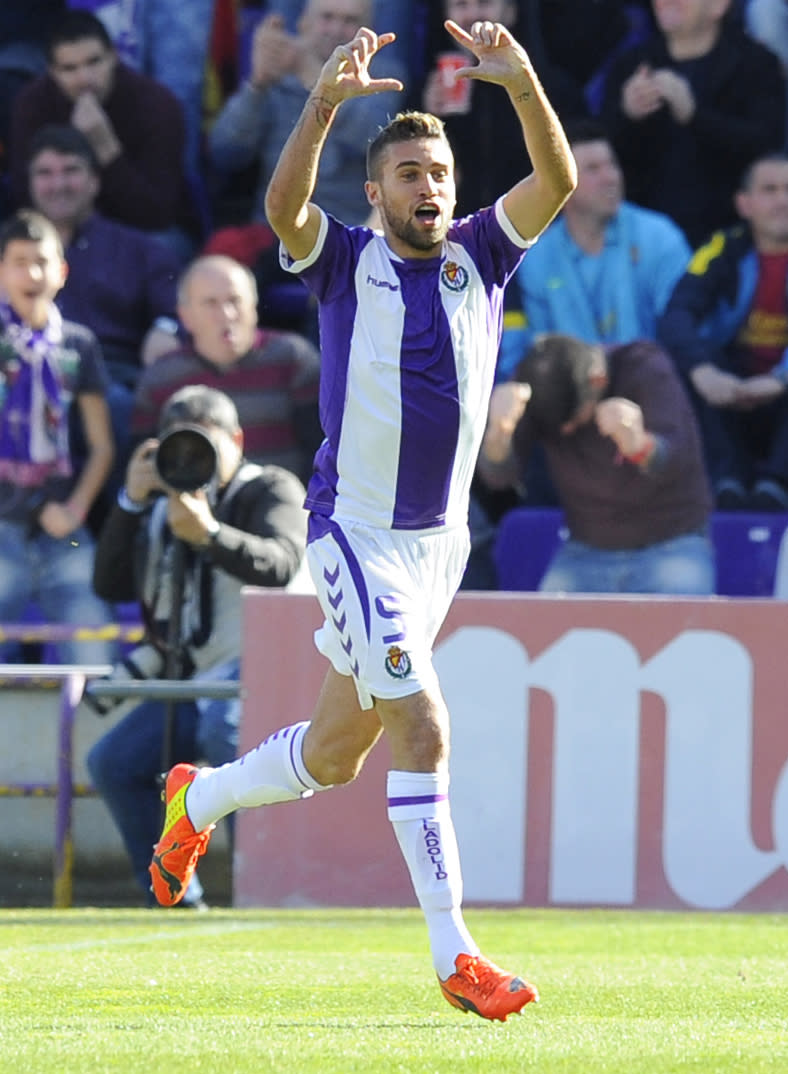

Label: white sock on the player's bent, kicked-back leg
[186,722,326,831]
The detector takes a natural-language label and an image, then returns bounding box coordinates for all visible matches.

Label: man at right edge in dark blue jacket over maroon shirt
[658,153,788,511]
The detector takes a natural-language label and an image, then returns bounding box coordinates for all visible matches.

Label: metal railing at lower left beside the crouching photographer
[0,623,240,908]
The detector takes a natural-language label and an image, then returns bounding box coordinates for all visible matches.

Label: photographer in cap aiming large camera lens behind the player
[87,386,306,908]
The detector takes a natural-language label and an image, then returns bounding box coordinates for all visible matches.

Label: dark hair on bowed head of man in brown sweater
[512,332,605,435]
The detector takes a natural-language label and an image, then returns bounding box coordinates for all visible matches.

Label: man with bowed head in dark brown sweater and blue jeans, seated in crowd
[478,334,715,595]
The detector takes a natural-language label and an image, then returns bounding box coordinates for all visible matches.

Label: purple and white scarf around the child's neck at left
[0,302,71,488]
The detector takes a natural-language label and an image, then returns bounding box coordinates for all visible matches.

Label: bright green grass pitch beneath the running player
[0,910,788,1074]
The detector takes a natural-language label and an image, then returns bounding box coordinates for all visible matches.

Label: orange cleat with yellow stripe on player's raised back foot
[148,765,216,906]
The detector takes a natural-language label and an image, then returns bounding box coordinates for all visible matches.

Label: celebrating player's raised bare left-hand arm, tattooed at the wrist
[265,27,403,260]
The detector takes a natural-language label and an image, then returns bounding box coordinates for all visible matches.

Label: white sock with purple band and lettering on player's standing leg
[386,771,479,981]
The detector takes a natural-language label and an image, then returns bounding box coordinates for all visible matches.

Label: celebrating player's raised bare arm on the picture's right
[444,19,578,238]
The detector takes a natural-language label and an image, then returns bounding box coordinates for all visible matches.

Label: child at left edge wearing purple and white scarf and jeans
[0,211,114,664]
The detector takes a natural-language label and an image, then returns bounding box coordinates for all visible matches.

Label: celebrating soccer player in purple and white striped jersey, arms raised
[150,21,577,1021]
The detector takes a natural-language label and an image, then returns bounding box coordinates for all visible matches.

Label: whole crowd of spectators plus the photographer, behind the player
[0,0,788,909]
